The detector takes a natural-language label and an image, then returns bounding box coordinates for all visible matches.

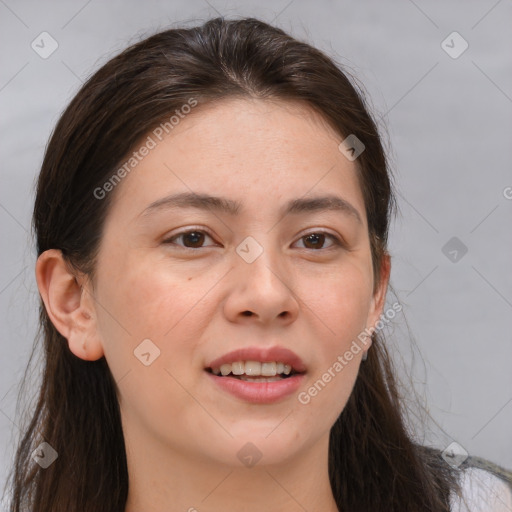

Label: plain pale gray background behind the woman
[0,0,512,496]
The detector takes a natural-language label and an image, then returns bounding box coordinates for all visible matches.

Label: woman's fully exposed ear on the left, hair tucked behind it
[36,249,104,361]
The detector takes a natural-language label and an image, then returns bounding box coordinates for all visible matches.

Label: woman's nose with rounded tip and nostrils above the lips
[224,245,299,325]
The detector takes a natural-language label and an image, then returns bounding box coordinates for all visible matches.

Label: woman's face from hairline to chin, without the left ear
[81,99,385,465]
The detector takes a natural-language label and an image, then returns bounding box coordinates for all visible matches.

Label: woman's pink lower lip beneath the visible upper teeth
[206,372,304,404]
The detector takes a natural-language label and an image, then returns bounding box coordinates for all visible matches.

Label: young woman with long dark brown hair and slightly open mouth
[3,19,508,512]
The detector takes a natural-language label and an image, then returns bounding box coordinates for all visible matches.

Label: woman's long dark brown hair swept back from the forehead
[4,18,456,512]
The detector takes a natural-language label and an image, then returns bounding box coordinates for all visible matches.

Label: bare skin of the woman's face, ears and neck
[36,99,390,512]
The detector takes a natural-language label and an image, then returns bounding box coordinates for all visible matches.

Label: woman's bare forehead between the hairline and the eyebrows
[105,98,364,228]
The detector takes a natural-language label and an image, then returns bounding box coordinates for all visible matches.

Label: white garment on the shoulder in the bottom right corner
[450,468,512,512]
